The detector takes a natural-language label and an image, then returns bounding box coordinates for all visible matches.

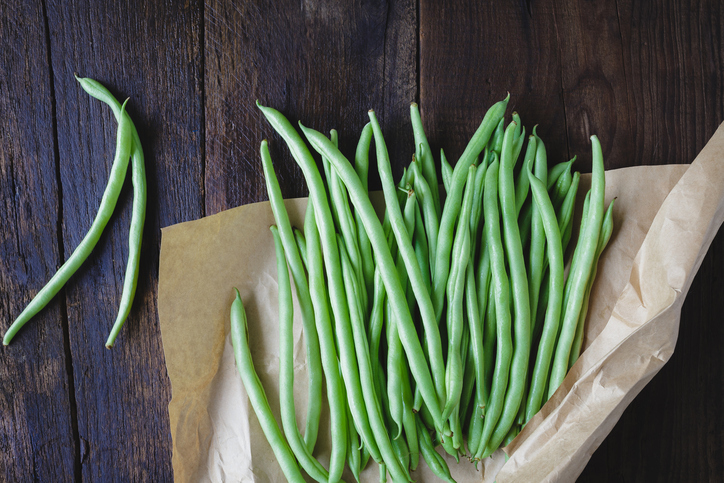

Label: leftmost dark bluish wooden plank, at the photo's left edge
[0,1,77,481]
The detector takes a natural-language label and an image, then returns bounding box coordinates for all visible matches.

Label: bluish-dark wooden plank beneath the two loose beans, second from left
[43,0,203,481]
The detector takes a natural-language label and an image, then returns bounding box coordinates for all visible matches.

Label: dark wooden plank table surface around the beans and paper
[0,0,724,482]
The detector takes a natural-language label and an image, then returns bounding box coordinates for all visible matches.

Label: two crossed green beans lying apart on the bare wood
[3,77,146,349]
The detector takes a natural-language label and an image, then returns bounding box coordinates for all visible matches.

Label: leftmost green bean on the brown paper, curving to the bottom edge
[230,289,304,483]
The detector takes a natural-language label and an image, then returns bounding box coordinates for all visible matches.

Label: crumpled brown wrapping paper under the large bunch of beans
[158,126,724,483]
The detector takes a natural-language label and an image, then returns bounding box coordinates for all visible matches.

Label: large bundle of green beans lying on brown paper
[231,98,613,482]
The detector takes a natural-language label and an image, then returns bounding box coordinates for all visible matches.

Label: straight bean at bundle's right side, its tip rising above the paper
[548,136,606,397]
